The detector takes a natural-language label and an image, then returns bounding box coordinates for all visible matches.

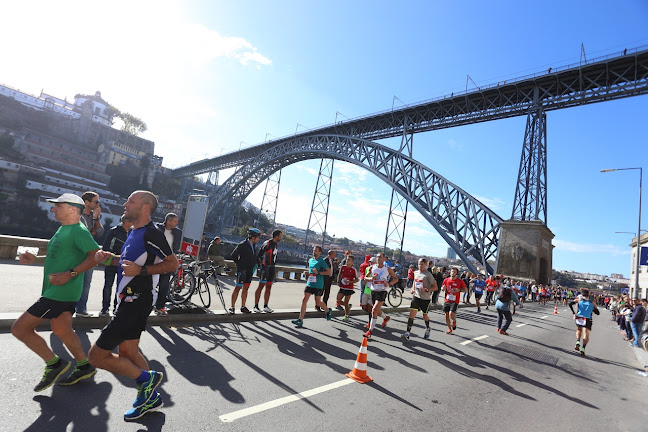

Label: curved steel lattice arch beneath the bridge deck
[210,135,502,274]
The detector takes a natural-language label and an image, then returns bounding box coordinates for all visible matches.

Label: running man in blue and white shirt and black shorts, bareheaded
[89,190,178,421]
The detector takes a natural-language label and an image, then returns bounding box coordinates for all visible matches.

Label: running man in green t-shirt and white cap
[11,193,99,392]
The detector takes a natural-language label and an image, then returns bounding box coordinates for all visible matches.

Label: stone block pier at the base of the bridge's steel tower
[497,220,554,284]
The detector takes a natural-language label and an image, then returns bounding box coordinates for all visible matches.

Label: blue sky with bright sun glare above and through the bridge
[0,1,648,277]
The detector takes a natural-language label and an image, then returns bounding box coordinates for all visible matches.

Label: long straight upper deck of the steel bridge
[174,47,648,177]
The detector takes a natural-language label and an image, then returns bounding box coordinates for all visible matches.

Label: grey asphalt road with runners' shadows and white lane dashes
[0,305,648,432]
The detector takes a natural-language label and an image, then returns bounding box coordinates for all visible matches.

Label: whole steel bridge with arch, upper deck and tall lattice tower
[173,47,648,272]
